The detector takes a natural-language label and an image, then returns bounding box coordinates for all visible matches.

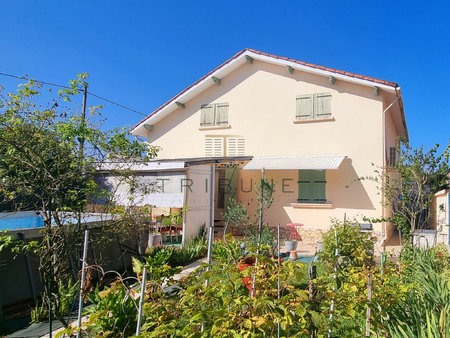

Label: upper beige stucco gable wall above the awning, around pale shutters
[148,61,383,162]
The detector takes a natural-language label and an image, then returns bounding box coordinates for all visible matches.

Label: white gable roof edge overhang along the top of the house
[131,48,398,137]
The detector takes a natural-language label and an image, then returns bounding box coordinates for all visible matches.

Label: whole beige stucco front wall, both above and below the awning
[144,61,396,235]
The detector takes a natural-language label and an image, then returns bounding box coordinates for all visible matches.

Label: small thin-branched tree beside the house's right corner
[383,139,450,239]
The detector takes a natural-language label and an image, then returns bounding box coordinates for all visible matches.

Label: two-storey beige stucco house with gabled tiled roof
[132,49,408,244]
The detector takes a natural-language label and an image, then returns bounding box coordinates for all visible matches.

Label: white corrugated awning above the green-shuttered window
[242,155,346,170]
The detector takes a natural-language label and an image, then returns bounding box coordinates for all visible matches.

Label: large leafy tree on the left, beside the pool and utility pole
[0,74,157,325]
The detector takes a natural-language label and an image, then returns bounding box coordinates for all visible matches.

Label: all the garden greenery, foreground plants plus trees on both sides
[0,74,450,337]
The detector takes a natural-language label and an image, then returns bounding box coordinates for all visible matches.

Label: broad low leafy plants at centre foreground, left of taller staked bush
[142,255,307,337]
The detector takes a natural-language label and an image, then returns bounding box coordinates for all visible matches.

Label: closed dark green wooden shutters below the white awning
[297,170,326,203]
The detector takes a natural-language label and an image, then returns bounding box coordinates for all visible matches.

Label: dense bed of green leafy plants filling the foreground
[59,221,450,337]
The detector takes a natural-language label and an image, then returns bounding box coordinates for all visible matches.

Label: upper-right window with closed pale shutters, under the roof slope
[295,93,331,120]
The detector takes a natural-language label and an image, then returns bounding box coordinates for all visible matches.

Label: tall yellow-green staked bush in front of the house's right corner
[311,221,409,337]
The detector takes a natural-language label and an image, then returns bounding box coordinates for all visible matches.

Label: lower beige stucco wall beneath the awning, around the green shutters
[237,159,381,231]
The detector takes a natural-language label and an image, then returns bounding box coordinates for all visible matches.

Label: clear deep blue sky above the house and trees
[0,0,450,147]
